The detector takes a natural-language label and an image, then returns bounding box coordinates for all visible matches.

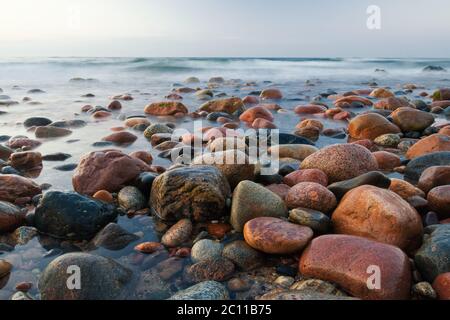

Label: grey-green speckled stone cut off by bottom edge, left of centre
[169,281,230,300]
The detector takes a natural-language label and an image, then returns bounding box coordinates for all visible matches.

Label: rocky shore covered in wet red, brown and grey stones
[0,77,450,300]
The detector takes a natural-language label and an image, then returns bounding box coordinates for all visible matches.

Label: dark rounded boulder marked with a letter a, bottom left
[39,252,132,300]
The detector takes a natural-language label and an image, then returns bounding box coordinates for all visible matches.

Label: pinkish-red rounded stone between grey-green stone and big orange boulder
[285,182,337,213]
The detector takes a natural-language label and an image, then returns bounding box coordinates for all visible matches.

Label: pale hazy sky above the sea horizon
[0,0,450,58]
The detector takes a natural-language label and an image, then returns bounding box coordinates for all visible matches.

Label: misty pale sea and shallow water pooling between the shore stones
[0,58,450,299]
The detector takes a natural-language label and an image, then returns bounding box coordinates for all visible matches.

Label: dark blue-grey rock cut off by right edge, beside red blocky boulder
[414,224,450,282]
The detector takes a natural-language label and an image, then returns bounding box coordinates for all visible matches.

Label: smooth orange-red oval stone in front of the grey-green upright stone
[244,217,313,254]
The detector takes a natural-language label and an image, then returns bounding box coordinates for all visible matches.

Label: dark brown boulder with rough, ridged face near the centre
[149,166,231,221]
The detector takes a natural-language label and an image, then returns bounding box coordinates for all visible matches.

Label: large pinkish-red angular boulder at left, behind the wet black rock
[72,150,150,195]
